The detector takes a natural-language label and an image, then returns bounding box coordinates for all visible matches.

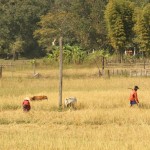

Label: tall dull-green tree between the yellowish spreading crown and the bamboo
[49,0,107,50]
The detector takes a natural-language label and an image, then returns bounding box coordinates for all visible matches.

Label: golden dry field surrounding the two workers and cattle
[0,68,150,150]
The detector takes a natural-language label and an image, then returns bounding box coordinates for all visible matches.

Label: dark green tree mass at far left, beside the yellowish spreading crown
[0,0,53,56]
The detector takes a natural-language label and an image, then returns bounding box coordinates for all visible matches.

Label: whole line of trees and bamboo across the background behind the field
[0,0,150,63]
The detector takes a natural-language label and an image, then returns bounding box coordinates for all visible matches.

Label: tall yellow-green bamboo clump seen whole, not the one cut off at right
[105,0,134,62]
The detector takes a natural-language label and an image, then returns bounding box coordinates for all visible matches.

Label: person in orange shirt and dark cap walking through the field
[129,86,139,106]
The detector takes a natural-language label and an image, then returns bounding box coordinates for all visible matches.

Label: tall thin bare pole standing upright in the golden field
[59,37,63,109]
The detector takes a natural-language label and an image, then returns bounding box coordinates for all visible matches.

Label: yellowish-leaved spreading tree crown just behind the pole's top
[34,11,72,51]
